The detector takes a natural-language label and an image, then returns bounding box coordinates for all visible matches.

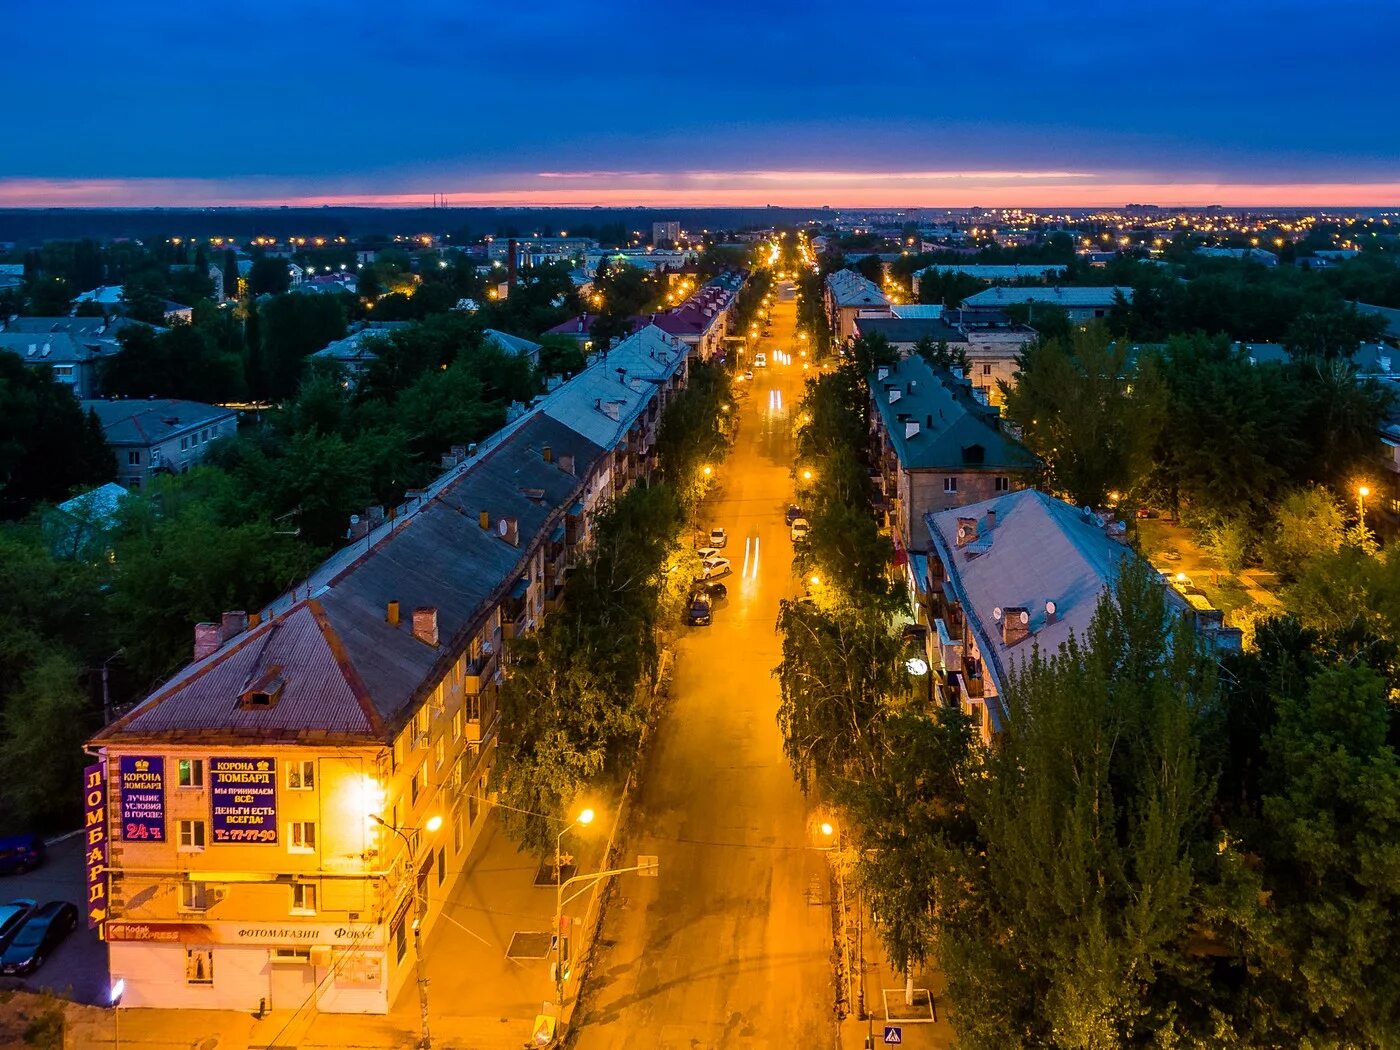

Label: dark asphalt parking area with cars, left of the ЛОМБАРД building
[0,834,108,1005]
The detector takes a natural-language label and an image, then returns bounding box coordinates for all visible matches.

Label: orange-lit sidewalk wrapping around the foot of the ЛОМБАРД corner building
[87,811,610,1050]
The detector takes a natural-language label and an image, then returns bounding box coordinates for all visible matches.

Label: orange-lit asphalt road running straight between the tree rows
[577,281,836,1050]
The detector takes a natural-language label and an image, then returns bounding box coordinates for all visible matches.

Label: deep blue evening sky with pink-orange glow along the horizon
[0,0,1400,207]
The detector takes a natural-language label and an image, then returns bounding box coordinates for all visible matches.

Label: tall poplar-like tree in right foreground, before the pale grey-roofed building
[937,561,1214,1049]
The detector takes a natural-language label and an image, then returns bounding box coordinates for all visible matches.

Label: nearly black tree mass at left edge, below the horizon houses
[0,353,116,518]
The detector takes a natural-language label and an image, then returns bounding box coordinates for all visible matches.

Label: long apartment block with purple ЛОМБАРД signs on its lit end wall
[87,329,687,1014]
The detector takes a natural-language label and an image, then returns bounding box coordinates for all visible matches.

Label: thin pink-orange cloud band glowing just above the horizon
[0,171,1400,209]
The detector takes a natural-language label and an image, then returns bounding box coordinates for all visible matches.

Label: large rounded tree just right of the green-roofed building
[1001,326,1166,507]
